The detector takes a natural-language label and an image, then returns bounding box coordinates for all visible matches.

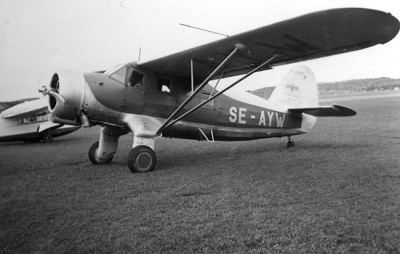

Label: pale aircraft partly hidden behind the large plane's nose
[0,98,80,143]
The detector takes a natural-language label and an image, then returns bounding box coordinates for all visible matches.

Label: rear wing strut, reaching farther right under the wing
[156,55,279,135]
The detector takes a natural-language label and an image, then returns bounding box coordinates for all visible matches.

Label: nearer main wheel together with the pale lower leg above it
[127,136,156,173]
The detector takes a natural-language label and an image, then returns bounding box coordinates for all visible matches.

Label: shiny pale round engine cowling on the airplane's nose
[47,71,86,125]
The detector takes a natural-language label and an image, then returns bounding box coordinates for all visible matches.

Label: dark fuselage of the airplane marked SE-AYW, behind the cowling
[71,69,307,141]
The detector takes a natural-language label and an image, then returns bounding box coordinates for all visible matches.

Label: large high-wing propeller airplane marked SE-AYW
[40,8,399,173]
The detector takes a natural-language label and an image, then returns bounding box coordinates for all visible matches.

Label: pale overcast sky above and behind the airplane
[0,0,400,101]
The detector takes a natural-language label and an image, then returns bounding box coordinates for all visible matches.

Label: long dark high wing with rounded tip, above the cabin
[138,8,399,82]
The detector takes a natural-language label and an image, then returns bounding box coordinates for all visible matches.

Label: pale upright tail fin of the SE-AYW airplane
[269,65,319,108]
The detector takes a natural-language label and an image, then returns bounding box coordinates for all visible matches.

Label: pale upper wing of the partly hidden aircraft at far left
[1,98,47,118]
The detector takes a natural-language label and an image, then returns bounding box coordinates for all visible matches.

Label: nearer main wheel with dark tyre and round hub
[128,146,156,173]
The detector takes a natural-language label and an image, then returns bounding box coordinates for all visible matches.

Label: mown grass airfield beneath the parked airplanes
[0,97,400,253]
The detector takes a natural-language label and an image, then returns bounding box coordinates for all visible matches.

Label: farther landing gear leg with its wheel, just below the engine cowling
[88,127,121,164]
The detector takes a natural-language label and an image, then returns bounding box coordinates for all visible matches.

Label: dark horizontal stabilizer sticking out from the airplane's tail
[289,104,357,116]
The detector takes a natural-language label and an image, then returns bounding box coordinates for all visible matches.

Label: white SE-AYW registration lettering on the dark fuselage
[229,107,285,127]
